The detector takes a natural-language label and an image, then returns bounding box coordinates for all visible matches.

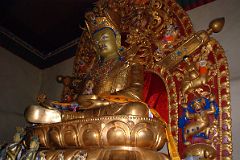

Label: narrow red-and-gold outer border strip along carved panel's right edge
[214,40,232,159]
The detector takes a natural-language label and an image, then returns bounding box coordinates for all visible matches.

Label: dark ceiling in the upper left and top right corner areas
[0,0,213,69]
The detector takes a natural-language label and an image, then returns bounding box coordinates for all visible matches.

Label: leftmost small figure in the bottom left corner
[6,127,26,160]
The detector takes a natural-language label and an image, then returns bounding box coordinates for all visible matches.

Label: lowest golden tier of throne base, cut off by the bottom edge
[42,147,169,160]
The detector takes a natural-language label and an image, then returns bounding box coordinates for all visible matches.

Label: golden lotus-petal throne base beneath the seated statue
[27,115,168,160]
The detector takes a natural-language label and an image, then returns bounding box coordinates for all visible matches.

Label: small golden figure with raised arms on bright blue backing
[179,95,219,145]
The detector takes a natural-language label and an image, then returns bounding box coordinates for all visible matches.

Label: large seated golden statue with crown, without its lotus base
[25,10,149,123]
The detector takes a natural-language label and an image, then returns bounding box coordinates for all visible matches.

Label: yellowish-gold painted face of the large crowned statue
[93,28,118,58]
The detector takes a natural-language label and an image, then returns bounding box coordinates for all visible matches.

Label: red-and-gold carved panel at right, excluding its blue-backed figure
[173,39,232,159]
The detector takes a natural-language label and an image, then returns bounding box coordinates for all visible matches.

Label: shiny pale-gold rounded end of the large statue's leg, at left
[24,105,62,123]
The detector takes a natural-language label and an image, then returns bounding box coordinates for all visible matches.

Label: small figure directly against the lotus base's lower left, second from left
[20,136,39,160]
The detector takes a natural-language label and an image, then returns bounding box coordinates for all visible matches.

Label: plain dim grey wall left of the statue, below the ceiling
[0,47,42,143]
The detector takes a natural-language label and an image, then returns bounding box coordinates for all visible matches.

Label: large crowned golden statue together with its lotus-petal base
[25,1,178,159]
